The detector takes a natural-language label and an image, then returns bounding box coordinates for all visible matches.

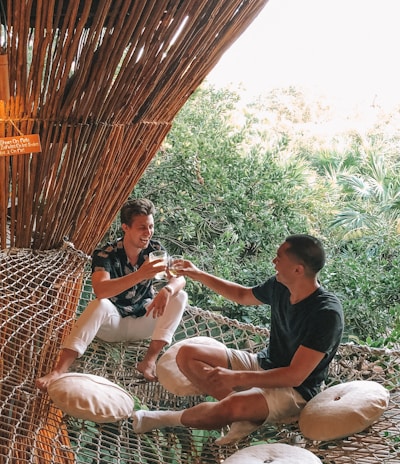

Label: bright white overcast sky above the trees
[207,0,400,111]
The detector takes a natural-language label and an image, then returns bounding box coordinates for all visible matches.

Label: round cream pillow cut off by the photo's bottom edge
[223,443,322,464]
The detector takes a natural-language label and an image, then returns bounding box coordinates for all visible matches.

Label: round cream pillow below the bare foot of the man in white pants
[47,372,134,423]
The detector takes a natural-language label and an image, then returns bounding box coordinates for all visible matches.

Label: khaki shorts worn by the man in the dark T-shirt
[227,349,307,424]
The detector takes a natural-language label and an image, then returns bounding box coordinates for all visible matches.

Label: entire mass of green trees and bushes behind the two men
[132,87,400,344]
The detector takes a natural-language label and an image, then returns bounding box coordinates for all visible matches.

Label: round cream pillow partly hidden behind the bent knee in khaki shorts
[157,337,225,396]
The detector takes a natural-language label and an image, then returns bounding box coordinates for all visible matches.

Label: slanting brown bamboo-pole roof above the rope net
[0,0,268,253]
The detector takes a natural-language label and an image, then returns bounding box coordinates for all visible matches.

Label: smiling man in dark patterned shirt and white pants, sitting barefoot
[36,199,187,391]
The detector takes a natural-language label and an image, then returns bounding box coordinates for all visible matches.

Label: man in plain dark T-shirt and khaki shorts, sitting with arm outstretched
[133,234,344,444]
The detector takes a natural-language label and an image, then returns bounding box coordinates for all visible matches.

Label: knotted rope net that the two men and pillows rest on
[0,245,400,464]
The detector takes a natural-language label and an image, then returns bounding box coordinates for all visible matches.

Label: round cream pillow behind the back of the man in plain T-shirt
[299,380,390,441]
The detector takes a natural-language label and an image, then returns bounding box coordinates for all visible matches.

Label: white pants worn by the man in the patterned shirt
[63,290,188,357]
